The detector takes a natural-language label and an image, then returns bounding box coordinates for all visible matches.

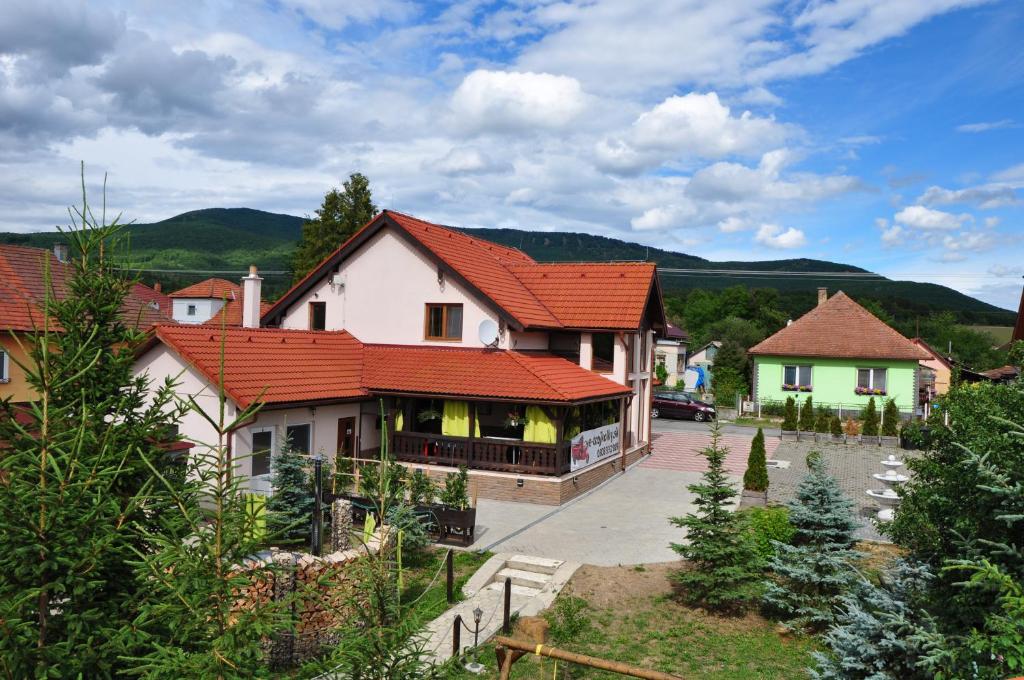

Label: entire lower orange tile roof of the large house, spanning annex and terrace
[149,325,630,408]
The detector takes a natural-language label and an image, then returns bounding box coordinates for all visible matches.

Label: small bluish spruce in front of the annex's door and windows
[266,445,315,539]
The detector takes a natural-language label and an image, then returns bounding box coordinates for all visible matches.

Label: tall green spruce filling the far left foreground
[0,171,184,677]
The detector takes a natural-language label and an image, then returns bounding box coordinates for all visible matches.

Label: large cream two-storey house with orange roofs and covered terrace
[136,210,666,505]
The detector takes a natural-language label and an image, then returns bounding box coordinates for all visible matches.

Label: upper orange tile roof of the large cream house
[269,210,656,330]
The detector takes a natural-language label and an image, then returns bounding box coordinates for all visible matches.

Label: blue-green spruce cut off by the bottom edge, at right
[810,560,941,680]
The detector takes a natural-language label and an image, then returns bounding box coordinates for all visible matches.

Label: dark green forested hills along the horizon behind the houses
[0,208,1015,326]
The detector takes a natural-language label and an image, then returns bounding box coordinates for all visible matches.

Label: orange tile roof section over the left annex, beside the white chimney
[148,324,368,409]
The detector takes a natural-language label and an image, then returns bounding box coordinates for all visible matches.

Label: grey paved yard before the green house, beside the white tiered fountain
[768,441,914,543]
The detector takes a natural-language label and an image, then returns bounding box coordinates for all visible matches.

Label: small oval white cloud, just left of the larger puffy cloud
[451,70,587,132]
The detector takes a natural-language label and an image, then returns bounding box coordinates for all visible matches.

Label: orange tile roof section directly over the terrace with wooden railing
[364,345,630,401]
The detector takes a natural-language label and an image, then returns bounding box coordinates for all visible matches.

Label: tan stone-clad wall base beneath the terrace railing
[402,444,650,505]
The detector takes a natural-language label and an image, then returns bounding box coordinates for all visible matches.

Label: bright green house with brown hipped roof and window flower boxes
[750,288,928,413]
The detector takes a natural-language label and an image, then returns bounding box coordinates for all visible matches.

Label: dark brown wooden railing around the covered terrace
[391,432,569,475]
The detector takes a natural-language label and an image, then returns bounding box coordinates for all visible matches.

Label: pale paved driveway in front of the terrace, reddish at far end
[474,426,753,566]
